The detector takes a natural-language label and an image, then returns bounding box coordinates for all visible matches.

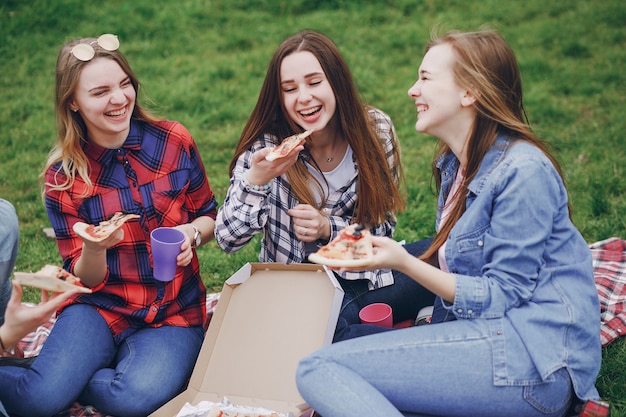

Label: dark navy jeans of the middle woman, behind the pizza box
[333,239,435,342]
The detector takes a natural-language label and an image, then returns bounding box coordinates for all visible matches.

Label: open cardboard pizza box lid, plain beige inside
[151,263,343,417]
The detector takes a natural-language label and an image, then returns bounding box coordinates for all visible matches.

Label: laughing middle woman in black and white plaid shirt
[215,31,434,341]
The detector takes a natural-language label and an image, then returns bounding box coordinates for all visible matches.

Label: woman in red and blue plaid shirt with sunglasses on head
[0,35,217,417]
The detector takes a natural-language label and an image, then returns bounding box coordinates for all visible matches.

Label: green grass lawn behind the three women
[0,0,626,416]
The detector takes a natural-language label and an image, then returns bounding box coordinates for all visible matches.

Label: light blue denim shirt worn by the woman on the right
[437,136,601,399]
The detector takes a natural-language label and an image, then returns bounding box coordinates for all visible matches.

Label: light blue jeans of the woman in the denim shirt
[296,319,573,417]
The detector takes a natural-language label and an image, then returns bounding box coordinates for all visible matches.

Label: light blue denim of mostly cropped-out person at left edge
[0,198,20,325]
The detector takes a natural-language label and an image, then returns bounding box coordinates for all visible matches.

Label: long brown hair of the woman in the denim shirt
[421,30,563,262]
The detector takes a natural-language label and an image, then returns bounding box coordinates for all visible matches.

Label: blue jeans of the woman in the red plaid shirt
[0,304,204,417]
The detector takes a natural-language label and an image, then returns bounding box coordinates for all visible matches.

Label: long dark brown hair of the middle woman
[230,30,404,226]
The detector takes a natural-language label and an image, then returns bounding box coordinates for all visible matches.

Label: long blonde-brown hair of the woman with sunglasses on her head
[40,38,162,195]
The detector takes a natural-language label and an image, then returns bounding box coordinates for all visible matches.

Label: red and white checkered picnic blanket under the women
[19,237,626,417]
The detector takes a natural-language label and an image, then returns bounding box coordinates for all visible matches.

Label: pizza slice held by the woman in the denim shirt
[309,224,373,268]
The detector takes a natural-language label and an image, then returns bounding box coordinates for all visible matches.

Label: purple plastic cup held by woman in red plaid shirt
[150,227,185,282]
